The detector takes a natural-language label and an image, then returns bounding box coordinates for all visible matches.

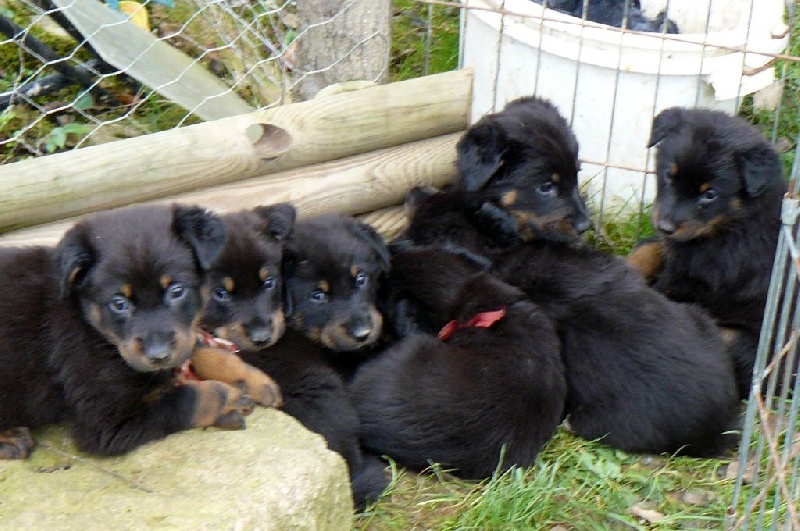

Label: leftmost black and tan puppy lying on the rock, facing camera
[0,206,252,458]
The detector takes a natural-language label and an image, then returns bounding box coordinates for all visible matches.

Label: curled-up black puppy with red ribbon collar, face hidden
[350,247,567,479]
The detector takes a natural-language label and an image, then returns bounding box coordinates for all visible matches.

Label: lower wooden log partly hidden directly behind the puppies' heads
[0,133,461,246]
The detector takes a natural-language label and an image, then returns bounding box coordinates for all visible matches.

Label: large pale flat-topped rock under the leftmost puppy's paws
[0,408,353,531]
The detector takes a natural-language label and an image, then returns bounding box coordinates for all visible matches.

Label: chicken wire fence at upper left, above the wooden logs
[0,0,388,163]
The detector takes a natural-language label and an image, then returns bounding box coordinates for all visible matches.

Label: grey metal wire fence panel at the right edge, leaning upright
[728,179,800,530]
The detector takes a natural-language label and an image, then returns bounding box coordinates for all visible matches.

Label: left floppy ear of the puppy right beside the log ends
[456,122,507,192]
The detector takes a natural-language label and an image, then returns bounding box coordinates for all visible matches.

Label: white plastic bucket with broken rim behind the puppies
[461,0,788,210]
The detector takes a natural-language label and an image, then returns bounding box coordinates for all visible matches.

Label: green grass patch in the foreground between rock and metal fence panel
[355,430,735,530]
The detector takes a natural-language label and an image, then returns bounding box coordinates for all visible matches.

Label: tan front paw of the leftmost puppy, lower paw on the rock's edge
[186,380,253,430]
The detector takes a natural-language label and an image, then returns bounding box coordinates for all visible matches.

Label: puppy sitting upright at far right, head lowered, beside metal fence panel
[628,108,786,398]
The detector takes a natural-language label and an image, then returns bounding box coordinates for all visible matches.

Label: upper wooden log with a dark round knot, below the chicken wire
[0,71,472,236]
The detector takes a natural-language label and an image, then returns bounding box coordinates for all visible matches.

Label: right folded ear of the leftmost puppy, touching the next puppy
[172,205,227,271]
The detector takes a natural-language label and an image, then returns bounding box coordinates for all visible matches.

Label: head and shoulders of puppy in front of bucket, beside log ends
[408,98,589,260]
